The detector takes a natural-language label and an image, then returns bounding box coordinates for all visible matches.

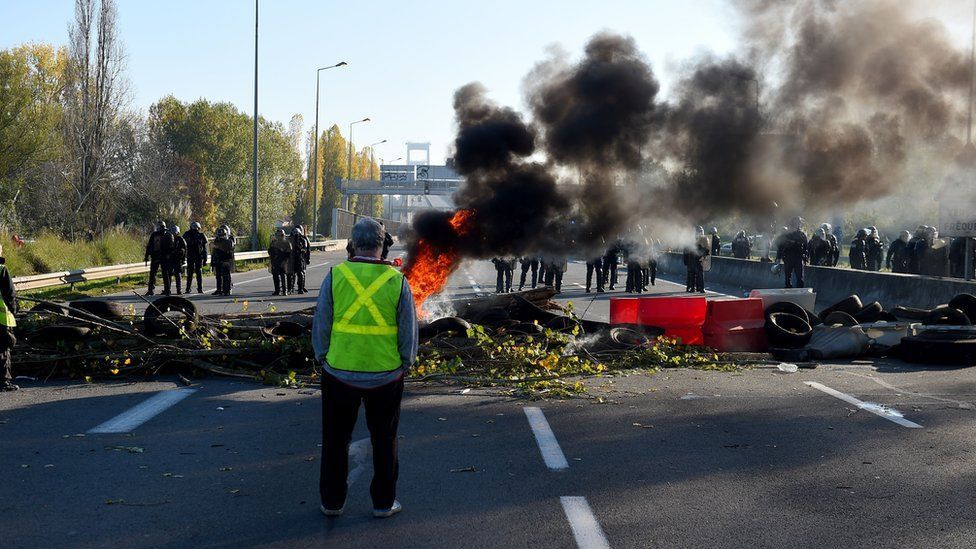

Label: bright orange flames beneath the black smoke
[404,210,474,317]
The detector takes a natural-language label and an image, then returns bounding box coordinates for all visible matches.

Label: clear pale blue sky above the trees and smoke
[0,0,967,162]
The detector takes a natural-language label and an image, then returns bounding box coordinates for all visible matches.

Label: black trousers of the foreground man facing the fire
[319,374,403,509]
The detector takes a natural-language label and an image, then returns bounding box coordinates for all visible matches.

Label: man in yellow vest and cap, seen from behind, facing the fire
[312,217,417,518]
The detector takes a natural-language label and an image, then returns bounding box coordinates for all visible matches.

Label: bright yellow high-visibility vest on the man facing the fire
[326,261,403,372]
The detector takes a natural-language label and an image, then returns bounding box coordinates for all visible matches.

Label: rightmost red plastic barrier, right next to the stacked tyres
[702,297,769,352]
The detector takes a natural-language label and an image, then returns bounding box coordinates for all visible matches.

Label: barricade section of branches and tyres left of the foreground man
[12,298,320,385]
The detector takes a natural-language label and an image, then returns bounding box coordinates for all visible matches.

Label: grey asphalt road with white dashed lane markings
[0,250,976,548]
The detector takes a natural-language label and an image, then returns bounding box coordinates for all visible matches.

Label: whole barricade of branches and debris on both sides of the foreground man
[13,290,734,397]
